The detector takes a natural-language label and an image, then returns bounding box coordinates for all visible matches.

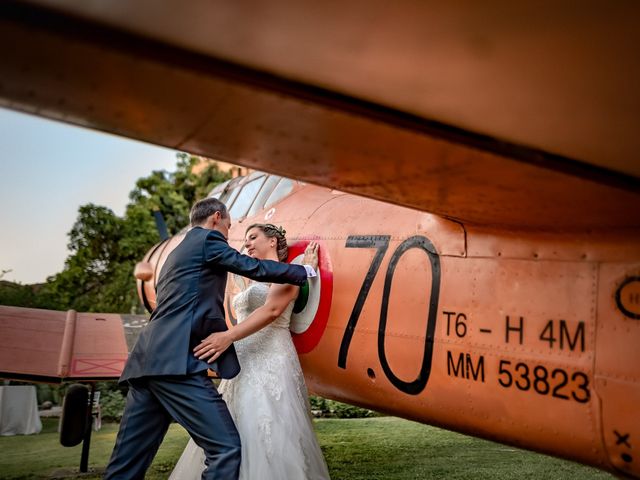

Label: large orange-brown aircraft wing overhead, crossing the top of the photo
[0,0,640,232]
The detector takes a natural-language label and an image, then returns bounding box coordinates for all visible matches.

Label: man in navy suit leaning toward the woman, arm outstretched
[104,198,315,479]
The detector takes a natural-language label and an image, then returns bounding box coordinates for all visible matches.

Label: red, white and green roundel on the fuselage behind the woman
[288,240,333,353]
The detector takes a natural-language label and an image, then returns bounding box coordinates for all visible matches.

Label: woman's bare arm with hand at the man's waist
[193,284,299,363]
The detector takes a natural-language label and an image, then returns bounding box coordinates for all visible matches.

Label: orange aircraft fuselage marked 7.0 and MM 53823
[131,172,640,476]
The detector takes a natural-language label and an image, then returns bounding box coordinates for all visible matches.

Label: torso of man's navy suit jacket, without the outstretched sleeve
[121,227,238,381]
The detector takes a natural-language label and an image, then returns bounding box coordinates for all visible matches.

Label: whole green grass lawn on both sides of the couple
[0,417,613,480]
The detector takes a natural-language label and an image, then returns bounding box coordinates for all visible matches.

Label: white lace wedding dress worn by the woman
[170,283,329,480]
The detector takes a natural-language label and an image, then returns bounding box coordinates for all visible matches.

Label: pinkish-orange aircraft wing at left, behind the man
[0,306,141,383]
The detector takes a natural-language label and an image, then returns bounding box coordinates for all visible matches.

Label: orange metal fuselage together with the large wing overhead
[0,0,640,478]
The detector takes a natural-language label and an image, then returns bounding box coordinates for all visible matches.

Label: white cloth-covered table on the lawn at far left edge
[0,385,42,436]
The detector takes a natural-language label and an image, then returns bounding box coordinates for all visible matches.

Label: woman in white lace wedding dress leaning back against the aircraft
[170,224,329,480]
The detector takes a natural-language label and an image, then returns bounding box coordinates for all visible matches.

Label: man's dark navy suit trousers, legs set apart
[104,374,241,480]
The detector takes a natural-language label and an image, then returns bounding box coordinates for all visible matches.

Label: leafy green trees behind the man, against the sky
[0,153,229,313]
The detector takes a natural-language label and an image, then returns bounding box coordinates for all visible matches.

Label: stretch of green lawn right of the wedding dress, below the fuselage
[316,417,614,480]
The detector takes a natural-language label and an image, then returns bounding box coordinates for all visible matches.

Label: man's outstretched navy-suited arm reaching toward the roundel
[205,232,313,285]
